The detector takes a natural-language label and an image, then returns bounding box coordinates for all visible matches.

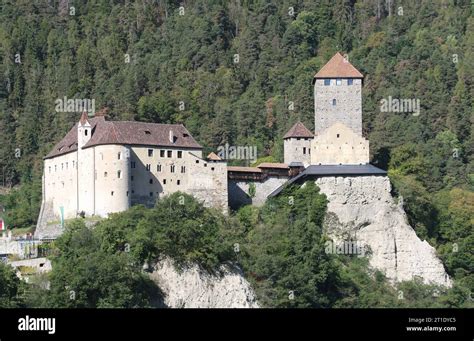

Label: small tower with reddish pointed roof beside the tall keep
[283,122,313,167]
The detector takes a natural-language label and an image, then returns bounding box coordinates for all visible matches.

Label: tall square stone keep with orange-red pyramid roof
[311,53,369,165]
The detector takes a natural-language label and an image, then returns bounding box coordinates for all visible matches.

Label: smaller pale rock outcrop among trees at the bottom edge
[150,258,259,308]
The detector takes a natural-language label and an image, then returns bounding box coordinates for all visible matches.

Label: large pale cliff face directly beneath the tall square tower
[316,176,451,287]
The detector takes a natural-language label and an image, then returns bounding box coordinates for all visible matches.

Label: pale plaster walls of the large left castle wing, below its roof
[38,115,228,230]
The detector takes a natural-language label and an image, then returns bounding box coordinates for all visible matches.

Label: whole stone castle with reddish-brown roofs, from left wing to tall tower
[36,53,385,239]
